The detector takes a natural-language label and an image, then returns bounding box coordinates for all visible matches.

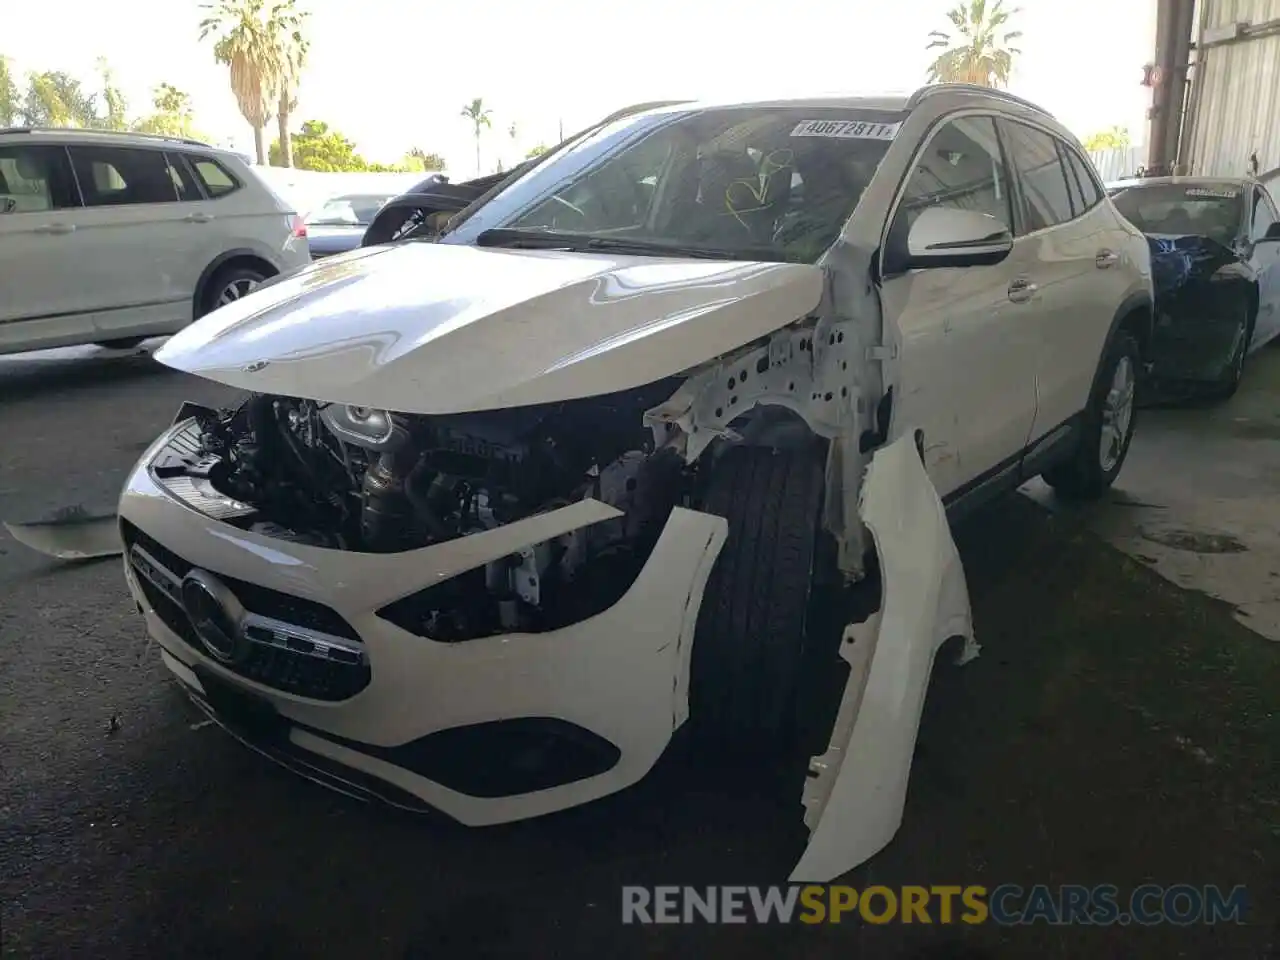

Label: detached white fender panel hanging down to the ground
[791,430,977,883]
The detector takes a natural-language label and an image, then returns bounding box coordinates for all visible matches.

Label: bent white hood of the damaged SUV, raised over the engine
[155,242,823,413]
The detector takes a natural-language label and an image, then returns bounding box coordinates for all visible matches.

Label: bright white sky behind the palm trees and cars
[0,0,1156,175]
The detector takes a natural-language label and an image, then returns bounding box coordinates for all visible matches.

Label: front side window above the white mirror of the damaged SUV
[890,116,1014,250]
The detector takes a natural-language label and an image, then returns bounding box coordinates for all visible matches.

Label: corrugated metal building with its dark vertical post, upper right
[1177,0,1280,183]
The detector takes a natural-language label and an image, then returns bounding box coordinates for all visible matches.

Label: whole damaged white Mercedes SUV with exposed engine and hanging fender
[119,84,1152,881]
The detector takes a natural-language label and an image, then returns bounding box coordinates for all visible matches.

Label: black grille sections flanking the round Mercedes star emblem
[120,521,372,701]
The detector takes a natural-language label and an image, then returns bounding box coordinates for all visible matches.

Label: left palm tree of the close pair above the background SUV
[200,0,283,164]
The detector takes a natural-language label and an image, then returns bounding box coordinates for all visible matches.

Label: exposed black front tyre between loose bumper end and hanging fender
[690,445,824,755]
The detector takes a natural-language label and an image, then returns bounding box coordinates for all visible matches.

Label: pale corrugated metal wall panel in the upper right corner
[1183,0,1280,177]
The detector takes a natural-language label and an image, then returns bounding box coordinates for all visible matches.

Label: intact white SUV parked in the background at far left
[0,128,311,353]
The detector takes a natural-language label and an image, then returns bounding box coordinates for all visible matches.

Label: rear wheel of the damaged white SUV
[1044,330,1142,499]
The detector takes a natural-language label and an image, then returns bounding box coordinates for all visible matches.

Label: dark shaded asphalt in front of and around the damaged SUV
[0,351,1280,960]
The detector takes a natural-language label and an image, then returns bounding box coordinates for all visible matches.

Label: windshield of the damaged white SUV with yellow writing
[445,106,902,262]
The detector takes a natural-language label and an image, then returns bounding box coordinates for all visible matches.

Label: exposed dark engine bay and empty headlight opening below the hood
[160,380,694,640]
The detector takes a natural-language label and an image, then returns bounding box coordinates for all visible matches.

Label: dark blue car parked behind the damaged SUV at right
[1107,177,1280,397]
